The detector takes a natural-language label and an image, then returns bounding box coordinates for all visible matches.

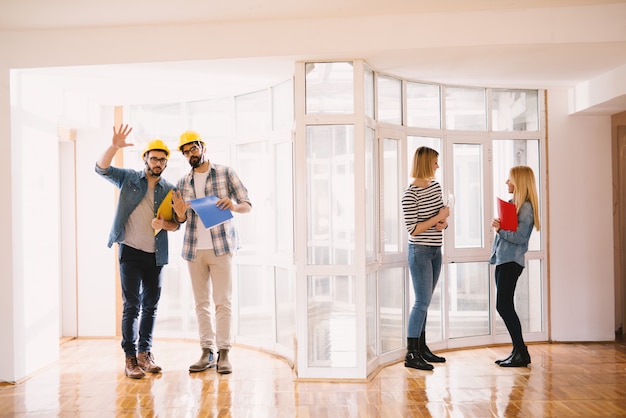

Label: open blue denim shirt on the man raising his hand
[96,164,174,266]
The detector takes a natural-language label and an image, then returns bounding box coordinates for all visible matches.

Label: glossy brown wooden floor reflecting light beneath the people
[0,339,626,418]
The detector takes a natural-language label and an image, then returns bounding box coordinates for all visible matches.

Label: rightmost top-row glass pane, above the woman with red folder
[491,89,539,131]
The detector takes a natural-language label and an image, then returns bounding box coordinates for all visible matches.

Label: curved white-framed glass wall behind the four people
[127,60,547,378]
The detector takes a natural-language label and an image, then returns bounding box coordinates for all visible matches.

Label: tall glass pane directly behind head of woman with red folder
[493,139,541,251]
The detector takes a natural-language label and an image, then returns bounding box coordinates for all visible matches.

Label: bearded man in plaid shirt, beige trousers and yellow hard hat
[172,131,252,374]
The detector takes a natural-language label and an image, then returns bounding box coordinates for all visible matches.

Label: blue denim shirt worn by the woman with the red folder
[489,201,535,267]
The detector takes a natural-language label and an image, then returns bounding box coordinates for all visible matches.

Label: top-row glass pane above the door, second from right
[446,87,487,131]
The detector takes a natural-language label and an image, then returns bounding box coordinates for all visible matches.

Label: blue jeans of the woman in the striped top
[407,244,441,338]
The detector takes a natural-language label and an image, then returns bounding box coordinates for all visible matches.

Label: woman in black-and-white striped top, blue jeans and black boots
[402,147,450,370]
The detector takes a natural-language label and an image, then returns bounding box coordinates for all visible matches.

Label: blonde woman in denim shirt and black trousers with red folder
[489,166,539,367]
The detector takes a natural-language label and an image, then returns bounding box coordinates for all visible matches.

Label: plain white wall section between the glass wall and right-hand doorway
[547,90,615,341]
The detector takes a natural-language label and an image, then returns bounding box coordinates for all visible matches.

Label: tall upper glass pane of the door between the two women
[452,144,485,248]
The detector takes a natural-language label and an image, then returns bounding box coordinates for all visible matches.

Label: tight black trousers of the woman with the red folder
[496,262,524,349]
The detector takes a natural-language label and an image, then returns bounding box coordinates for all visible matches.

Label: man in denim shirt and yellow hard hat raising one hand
[96,125,179,379]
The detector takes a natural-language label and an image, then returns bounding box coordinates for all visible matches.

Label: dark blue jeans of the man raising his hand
[119,244,162,356]
